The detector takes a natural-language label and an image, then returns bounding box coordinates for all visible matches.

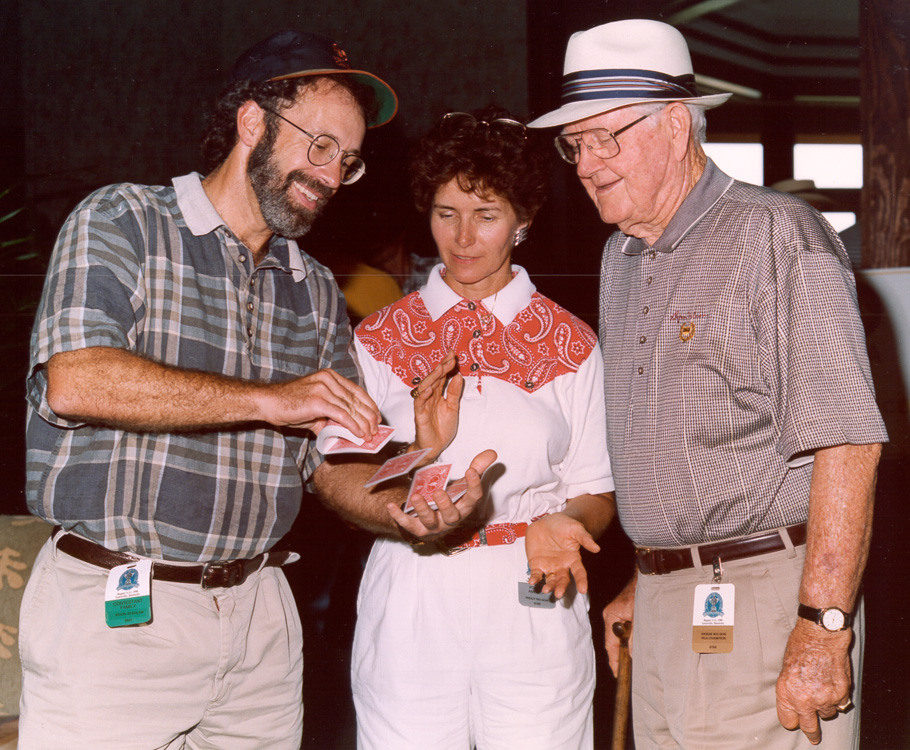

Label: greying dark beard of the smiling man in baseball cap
[247,132,332,239]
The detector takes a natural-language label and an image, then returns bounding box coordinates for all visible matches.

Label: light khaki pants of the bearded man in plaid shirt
[19,540,303,750]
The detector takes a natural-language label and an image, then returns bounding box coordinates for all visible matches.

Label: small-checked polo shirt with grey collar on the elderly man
[600,161,887,547]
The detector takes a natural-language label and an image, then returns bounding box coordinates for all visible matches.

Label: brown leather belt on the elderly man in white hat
[635,523,806,576]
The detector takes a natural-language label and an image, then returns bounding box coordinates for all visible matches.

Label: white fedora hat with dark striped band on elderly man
[528,20,732,128]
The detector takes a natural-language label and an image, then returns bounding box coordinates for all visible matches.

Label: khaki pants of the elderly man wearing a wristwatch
[632,546,863,750]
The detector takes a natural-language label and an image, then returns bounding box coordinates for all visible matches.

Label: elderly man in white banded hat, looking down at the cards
[531,20,887,750]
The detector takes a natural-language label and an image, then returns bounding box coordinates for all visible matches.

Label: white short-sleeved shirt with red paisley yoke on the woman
[355,264,613,523]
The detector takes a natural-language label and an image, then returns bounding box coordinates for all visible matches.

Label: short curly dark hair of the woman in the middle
[410,106,549,221]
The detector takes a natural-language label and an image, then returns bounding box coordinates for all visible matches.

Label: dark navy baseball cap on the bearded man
[230,30,398,128]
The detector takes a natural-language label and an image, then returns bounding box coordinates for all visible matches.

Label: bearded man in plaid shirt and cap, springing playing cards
[19,31,491,750]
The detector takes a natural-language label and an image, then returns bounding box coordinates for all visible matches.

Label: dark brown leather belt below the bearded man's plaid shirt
[54,526,293,589]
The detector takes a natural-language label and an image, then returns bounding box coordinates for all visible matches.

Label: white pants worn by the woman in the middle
[352,539,594,750]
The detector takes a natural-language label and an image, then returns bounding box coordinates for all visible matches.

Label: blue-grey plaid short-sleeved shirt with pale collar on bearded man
[26,174,359,561]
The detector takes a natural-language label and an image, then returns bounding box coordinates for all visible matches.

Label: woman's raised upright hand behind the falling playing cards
[414,352,464,464]
